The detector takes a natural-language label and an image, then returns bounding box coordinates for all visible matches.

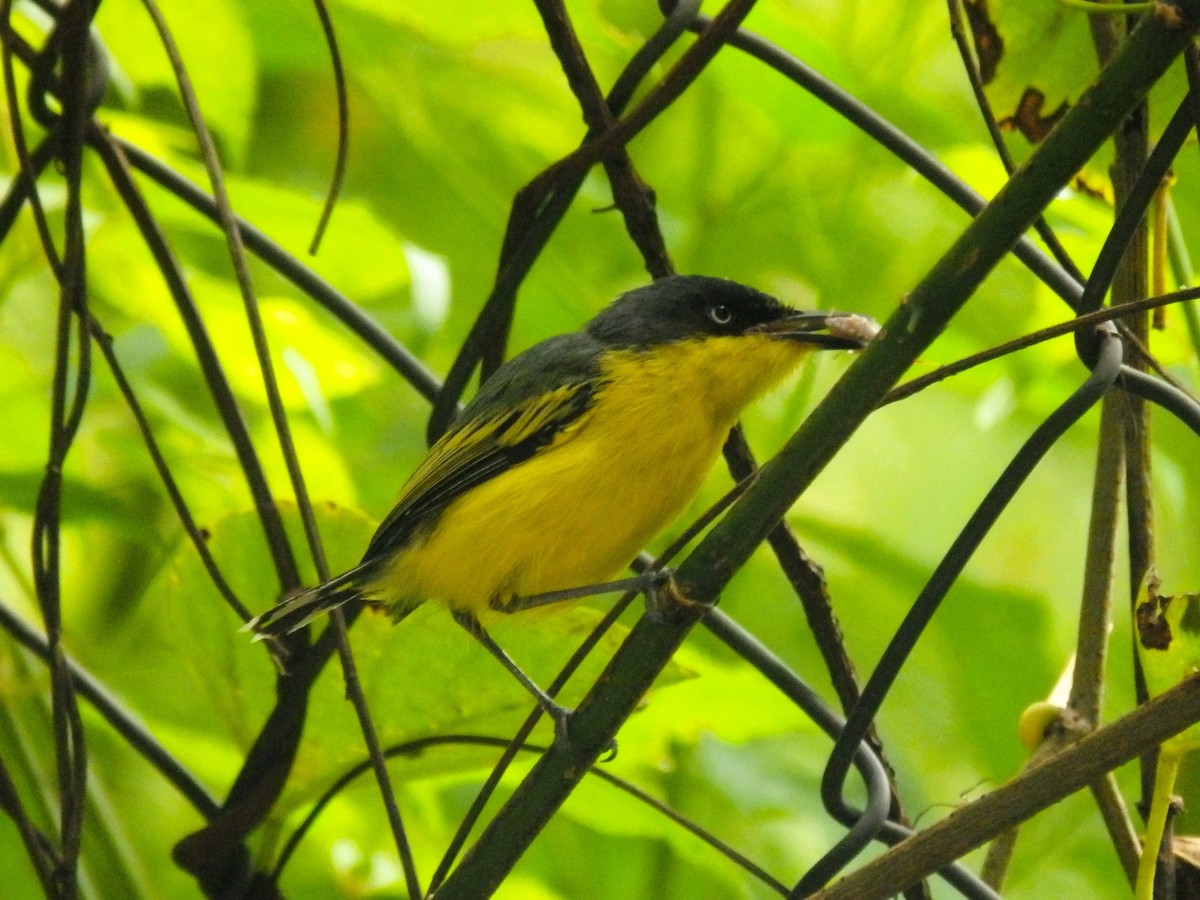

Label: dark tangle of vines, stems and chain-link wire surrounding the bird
[0,0,1200,900]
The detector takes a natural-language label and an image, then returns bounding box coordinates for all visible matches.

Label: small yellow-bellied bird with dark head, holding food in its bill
[246,276,877,728]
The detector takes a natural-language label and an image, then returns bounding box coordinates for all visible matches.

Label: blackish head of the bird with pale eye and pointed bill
[587,275,863,349]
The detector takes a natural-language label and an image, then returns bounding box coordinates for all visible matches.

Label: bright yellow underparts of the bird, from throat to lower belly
[364,336,805,612]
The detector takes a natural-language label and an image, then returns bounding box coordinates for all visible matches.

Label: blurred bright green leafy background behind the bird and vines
[0,0,1200,900]
